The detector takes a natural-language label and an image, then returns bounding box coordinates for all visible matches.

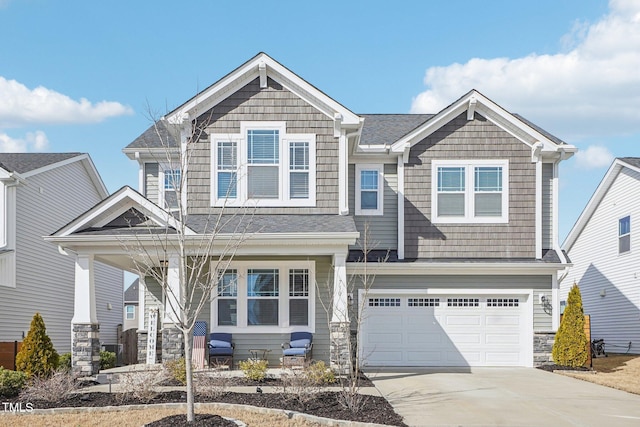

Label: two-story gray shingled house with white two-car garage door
[50,53,576,374]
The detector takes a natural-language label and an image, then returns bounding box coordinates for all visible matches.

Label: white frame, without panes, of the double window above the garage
[431,160,509,224]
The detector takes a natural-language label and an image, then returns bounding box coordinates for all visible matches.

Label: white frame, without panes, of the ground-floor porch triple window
[210,261,316,333]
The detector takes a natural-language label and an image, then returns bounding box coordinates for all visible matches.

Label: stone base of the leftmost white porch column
[71,323,100,377]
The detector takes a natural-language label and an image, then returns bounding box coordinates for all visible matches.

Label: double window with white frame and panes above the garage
[431,160,509,223]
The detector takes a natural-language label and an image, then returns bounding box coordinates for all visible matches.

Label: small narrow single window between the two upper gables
[356,164,384,215]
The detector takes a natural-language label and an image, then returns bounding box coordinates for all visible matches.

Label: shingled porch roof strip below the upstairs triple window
[187,215,357,233]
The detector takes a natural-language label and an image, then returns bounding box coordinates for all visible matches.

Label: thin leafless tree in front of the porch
[121,109,253,422]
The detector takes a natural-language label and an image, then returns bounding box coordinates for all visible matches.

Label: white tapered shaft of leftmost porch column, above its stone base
[71,254,98,324]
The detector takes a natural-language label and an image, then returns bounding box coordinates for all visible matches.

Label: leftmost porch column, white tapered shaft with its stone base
[71,254,100,376]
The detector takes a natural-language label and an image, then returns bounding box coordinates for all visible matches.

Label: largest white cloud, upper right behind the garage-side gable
[411,0,640,139]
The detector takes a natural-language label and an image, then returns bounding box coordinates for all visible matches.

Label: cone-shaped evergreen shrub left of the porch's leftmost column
[16,313,59,377]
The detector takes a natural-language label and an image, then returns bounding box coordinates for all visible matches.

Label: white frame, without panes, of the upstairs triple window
[211,122,316,207]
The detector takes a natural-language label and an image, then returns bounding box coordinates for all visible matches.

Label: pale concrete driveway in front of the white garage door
[366,368,640,427]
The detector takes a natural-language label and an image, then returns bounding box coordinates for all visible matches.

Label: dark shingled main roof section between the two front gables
[360,114,434,145]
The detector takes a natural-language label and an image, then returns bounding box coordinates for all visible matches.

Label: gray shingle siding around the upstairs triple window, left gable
[187,79,338,214]
